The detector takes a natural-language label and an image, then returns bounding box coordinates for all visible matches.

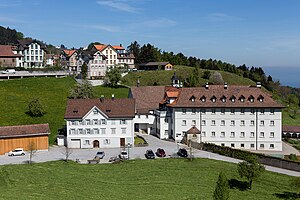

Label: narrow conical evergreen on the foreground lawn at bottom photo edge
[213,172,229,200]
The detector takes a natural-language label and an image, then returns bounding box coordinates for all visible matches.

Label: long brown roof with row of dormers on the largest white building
[170,85,284,108]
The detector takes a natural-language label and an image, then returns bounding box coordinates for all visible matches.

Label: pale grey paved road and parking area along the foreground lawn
[0,135,300,176]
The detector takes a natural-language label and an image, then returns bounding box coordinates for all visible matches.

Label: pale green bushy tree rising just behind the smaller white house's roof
[69,80,94,99]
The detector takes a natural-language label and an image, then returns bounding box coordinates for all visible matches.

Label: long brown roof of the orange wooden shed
[0,124,50,138]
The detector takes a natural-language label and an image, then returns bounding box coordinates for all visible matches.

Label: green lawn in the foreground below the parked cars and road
[0,159,293,200]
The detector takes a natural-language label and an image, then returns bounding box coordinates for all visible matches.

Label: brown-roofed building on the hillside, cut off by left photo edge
[0,45,22,68]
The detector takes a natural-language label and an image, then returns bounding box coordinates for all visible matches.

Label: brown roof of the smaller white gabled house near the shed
[65,98,135,119]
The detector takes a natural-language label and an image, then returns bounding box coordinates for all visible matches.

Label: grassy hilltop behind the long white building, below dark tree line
[122,66,255,86]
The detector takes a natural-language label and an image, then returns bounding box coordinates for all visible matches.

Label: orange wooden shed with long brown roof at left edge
[0,124,50,155]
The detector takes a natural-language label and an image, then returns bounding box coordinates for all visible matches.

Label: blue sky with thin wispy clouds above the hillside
[0,0,300,67]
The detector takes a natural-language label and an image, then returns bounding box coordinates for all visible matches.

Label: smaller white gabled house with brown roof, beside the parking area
[65,98,134,148]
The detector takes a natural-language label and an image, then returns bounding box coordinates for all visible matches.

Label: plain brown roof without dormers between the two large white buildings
[130,86,165,113]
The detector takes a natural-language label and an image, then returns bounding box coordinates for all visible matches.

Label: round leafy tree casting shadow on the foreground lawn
[238,156,265,189]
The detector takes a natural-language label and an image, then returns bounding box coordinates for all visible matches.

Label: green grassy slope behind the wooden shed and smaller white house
[0,77,128,144]
